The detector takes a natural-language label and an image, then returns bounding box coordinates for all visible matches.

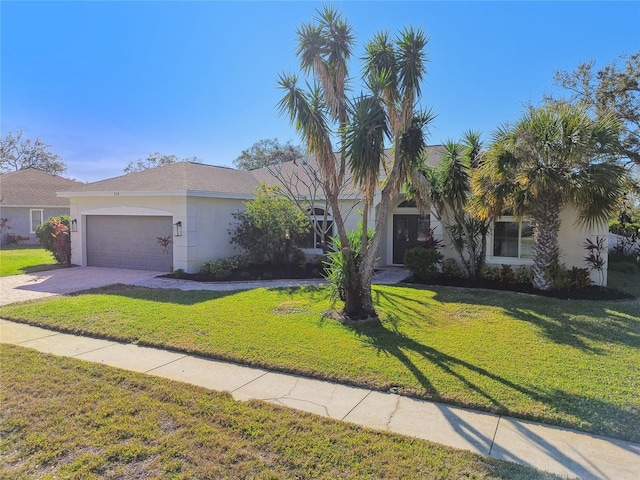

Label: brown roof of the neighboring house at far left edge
[0,168,82,207]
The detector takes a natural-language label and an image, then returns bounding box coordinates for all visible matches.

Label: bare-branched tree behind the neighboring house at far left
[0,130,67,175]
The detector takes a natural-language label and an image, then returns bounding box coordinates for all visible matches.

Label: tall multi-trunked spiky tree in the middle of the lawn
[279,7,433,320]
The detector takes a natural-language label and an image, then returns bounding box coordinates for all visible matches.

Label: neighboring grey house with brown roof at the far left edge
[0,168,82,243]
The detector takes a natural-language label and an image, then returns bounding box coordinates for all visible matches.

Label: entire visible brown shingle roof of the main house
[60,146,442,198]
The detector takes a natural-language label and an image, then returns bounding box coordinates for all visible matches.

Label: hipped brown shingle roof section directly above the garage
[62,161,258,195]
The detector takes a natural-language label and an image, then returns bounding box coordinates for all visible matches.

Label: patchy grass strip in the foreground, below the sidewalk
[0,345,558,480]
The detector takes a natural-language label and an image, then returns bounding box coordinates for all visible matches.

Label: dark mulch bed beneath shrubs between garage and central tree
[163,263,324,282]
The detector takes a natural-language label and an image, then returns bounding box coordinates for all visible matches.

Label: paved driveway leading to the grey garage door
[0,267,162,305]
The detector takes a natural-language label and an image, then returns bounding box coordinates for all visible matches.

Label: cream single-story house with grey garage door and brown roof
[58,147,607,283]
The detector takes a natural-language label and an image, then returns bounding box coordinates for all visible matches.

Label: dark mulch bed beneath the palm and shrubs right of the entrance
[404,277,635,300]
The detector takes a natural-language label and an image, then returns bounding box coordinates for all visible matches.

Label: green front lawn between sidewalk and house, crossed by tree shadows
[0,286,640,441]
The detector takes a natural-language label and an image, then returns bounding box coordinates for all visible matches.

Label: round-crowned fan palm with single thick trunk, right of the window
[473,103,625,290]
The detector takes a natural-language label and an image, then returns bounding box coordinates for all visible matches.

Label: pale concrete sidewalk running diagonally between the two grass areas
[0,319,640,480]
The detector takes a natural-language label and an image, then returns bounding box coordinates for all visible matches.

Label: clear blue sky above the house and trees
[0,0,640,181]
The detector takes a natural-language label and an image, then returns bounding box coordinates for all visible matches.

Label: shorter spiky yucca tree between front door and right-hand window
[410,131,494,280]
